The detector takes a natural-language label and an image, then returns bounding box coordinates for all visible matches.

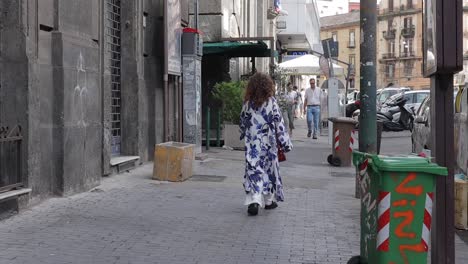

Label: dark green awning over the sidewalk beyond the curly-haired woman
[203,41,277,58]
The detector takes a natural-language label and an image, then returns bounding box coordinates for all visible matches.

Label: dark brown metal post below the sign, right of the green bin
[431,74,455,264]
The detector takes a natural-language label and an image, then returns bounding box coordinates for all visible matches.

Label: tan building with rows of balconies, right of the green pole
[377,0,430,89]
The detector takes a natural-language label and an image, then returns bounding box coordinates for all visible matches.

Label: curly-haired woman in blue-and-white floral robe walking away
[240,73,292,215]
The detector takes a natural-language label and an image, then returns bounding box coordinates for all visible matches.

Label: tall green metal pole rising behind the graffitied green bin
[359,0,377,154]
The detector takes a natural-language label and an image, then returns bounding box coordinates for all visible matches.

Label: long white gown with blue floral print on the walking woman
[240,97,292,207]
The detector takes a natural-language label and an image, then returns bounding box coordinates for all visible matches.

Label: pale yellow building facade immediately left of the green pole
[320,11,361,89]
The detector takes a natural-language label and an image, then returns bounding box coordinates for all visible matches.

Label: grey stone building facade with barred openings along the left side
[0,0,188,206]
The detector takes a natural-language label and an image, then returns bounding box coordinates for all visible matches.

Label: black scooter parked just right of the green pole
[377,93,415,132]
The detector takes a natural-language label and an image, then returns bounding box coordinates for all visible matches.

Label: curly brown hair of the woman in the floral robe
[244,73,275,107]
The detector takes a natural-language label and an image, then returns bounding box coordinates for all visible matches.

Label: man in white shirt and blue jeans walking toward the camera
[304,79,322,139]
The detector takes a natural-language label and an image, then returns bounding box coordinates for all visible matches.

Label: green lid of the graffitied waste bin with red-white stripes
[353,151,448,176]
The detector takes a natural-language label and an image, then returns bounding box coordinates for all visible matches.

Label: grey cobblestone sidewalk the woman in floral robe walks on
[0,120,468,264]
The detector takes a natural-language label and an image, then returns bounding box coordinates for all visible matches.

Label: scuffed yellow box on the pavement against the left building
[153,142,195,182]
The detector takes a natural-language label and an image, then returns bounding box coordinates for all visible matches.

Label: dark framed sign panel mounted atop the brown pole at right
[423,0,463,77]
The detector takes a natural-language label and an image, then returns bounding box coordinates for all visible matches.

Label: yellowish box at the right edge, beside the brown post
[455,179,468,230]
